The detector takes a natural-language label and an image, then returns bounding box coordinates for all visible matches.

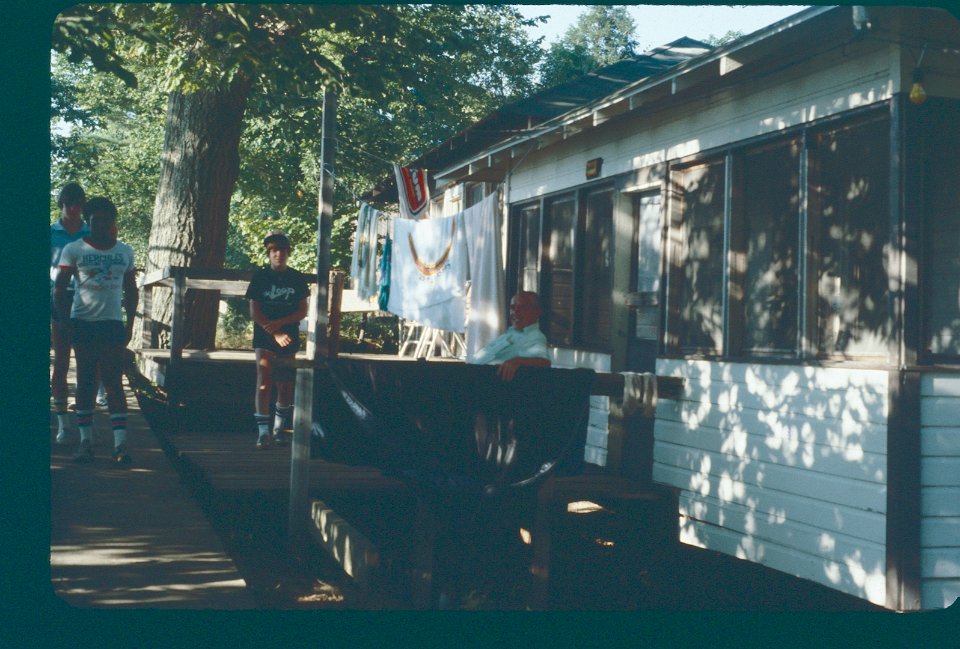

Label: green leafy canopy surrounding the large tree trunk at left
[51,4,540,270]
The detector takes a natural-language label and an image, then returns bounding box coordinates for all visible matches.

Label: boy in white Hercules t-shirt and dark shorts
[54,198,137,464]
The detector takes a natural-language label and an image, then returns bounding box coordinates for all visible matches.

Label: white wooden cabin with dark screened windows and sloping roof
[380,7,960,610]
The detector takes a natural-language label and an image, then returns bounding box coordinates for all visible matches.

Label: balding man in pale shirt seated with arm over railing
[472,291,550,381]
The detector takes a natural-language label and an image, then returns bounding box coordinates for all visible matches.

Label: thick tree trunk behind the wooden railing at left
[146,78,251,349]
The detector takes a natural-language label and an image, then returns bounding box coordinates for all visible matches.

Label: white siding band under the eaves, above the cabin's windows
[509,43,899,203]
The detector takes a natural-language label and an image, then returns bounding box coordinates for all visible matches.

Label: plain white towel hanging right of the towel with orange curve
[463,192,506,363]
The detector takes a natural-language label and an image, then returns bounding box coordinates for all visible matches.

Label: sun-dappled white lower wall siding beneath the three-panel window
[653,359,888,605]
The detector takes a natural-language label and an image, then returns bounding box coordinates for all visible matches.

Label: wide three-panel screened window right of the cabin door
[665,111,896,358]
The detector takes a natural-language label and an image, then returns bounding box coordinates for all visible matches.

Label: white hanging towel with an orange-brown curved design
[387,213,468,332]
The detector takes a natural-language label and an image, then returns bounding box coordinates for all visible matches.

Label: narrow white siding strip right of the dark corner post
[920,374,960,609]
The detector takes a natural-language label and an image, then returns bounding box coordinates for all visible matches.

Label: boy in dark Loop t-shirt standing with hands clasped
[246,232,310,449]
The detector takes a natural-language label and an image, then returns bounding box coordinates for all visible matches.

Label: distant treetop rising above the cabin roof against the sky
[540,5,637,88]
